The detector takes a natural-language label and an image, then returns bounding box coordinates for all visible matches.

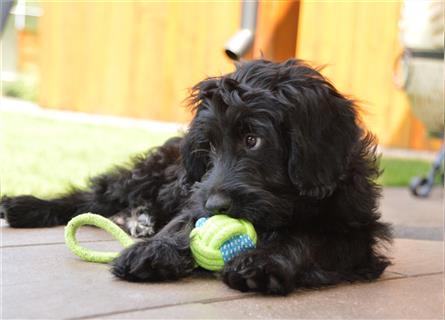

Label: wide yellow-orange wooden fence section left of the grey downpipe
[39,1,240,121]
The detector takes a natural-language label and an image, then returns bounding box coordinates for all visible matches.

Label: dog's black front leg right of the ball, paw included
[222,233,390,295]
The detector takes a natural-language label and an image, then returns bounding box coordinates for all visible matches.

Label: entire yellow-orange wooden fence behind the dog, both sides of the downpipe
[39,0,438,148]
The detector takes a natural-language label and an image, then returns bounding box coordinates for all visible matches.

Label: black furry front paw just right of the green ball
[222,251,294,295]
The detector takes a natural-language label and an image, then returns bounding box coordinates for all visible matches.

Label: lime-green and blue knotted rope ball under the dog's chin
[190,215,257,271]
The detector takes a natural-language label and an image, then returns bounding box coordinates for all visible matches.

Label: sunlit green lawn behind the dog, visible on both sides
[0,112,436,196]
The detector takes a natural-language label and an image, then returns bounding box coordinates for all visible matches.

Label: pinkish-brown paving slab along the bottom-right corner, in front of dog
[195,274,444,319]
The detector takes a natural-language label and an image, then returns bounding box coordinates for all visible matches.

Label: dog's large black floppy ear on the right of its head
[281,62,361,199]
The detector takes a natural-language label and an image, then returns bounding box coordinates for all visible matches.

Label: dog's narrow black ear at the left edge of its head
[181,78,217,182]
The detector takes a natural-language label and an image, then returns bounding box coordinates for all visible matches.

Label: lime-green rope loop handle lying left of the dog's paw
[65,213,134,263]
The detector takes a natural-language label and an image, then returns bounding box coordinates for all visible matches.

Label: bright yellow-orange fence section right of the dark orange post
[296,0,437,148]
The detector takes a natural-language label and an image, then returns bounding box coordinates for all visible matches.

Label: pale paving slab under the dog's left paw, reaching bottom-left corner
[2,242,243,319]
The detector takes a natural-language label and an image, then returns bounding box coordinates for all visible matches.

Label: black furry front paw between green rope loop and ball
[111,238,194,282]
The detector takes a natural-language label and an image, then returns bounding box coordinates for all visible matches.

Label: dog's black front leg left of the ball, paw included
[112,210,201,282]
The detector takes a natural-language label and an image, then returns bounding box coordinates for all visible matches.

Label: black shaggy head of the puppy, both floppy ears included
[182,60,361,228]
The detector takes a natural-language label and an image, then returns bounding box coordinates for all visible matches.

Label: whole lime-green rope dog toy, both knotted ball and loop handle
[65,213,257,271]
